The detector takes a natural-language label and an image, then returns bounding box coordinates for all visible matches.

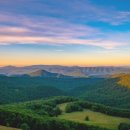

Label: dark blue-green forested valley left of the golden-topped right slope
[0,76,101,104]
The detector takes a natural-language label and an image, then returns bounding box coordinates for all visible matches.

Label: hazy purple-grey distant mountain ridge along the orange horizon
[0,65,130,77]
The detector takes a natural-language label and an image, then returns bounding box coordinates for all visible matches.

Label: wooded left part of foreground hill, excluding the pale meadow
[0,97,111,130]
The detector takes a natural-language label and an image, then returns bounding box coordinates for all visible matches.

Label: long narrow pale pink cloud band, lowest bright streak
[0,36,121,49]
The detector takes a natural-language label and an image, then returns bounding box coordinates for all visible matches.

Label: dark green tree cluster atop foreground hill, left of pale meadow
[26,97,76,116]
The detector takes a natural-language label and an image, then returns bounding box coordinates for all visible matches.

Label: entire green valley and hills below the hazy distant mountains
[0,66,130,130]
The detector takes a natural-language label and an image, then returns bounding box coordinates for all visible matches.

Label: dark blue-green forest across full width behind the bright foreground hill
[0,75,130,109]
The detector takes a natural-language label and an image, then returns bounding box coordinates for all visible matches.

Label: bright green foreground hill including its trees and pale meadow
[0,97,130,130]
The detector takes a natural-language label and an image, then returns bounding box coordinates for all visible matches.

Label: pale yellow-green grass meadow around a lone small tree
[59,104,130,130]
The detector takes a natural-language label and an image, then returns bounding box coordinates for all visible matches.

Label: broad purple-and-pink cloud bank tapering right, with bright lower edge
[0,12,127,49]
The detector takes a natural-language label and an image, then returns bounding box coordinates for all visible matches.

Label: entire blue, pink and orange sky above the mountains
[0,0,130,66]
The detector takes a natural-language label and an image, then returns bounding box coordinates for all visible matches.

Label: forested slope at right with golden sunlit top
[70,75,130,109]
